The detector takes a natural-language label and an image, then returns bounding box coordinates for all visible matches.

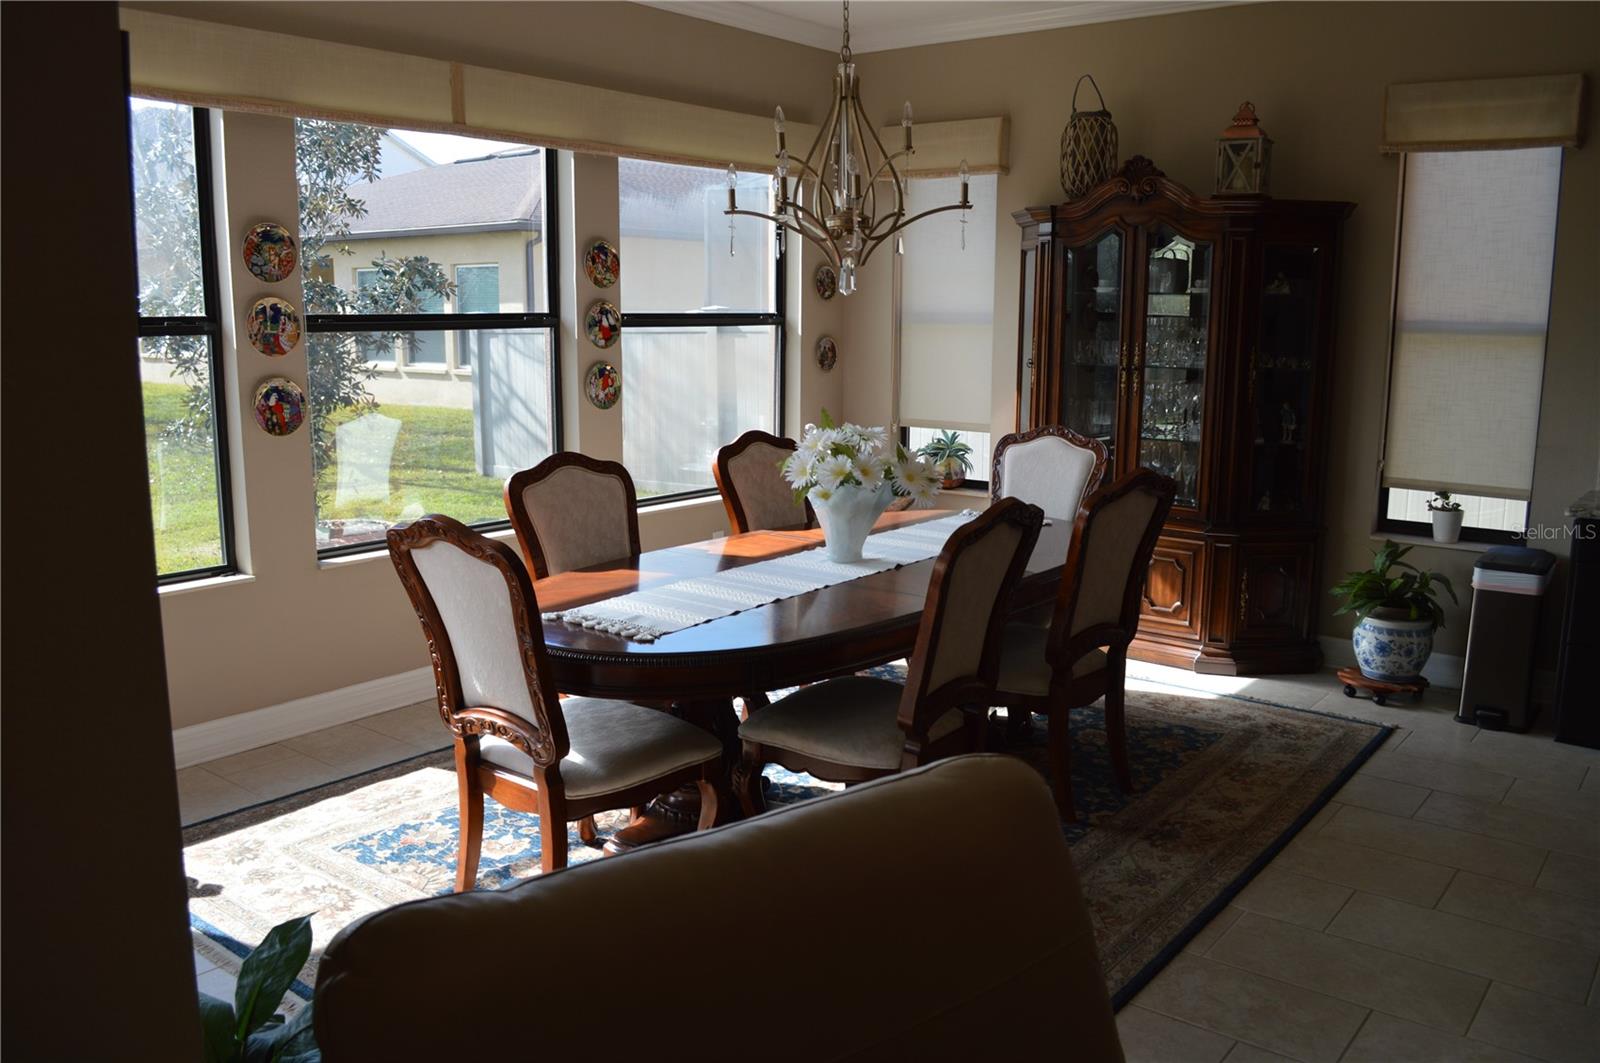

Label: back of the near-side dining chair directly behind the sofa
[899,498,1045,736]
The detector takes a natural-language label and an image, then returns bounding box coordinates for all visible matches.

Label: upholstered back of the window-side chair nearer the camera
[506,451,638,580]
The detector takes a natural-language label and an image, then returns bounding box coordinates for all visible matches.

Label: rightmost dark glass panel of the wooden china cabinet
[1246,243,1322,514]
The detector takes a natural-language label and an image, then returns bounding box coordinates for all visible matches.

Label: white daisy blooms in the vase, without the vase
[782,410,941,507]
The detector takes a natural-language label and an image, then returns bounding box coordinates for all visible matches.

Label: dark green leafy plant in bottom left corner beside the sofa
[200,916,322,1063]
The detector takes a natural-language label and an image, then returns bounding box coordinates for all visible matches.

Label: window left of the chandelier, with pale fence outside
[618,158,784,499]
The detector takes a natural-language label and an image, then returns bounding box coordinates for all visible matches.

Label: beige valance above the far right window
[1379,74,1587,154]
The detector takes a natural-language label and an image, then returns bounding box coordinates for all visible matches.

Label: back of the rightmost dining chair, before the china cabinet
[1046,469,1178,676]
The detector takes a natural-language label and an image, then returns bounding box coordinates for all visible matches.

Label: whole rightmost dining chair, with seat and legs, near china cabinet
[994,469,1178,820]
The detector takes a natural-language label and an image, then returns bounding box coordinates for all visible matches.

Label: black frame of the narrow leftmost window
[128,100,238,586]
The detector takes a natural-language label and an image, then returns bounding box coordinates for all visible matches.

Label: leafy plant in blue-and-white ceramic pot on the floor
[1333,540,1459,682]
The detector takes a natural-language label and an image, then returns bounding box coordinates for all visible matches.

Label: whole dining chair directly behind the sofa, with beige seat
[733,498,1043,815]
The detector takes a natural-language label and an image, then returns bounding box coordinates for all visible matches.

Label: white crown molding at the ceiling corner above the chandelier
[643,0,1251,54]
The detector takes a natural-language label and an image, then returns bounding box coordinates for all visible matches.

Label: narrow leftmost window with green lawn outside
[130,98,234,581]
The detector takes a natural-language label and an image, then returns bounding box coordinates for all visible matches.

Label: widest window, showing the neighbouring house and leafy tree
[296,118,560,554]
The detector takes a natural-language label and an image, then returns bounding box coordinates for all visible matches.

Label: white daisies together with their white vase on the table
[782,410,939,564]
